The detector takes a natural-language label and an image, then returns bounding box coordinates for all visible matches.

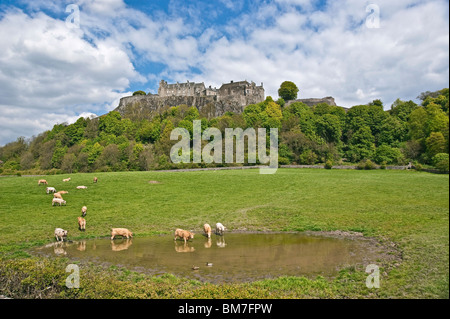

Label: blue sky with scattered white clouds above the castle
[0,0,449,146]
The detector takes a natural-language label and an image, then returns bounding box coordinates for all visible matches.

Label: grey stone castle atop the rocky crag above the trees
[115,80,265,117]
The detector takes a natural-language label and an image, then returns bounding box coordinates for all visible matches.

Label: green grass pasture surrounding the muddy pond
[0,169,449,298]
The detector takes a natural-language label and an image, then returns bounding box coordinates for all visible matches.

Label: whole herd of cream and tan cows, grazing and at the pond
[38,177,226,243]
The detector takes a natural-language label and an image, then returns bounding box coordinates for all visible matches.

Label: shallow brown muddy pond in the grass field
[34,233,382,283]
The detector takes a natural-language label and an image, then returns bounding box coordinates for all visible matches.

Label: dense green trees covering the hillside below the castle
[0,88,449,175]
